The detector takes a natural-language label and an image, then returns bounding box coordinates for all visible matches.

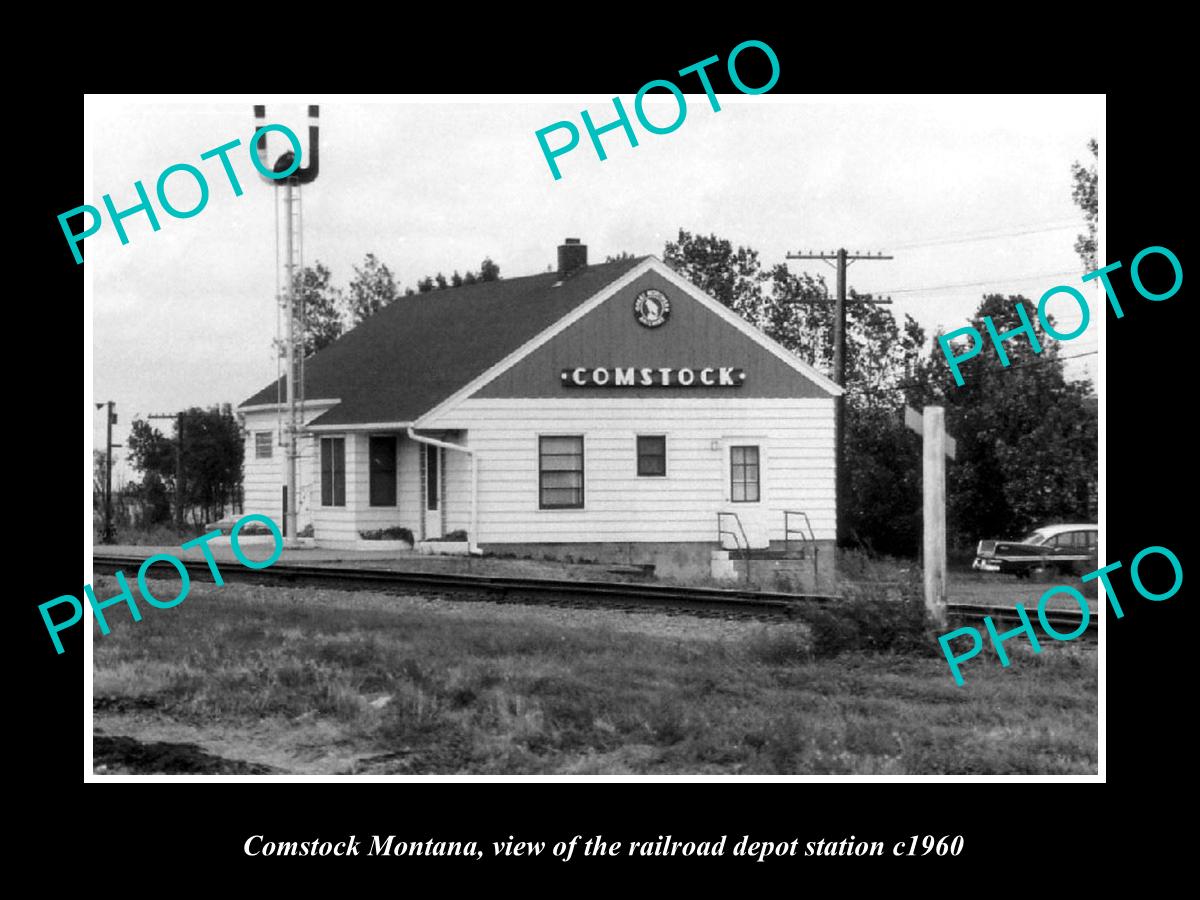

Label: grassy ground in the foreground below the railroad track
[94,576,1097,774]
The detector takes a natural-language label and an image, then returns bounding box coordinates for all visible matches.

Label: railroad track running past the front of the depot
[92,553,1096,638]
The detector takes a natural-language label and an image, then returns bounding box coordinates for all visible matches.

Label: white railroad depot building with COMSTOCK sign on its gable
[240,239,840,576]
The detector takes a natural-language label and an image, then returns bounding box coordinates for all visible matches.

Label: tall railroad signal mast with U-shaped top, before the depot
[254,106,320,541]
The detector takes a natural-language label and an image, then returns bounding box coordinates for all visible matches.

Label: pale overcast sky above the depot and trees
[87,94,1104,480]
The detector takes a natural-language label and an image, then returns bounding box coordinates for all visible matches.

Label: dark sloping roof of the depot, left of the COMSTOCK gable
[240,257,646,425]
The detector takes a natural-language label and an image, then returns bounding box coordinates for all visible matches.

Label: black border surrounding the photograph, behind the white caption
[23,15,1194,893]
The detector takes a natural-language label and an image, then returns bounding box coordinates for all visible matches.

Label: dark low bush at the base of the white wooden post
[803,584,937,659]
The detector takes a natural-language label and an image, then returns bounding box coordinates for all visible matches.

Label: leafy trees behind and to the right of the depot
[662,133,1098,556]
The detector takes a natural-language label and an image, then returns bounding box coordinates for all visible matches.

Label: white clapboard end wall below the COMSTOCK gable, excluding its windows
[422,397,836,546]
